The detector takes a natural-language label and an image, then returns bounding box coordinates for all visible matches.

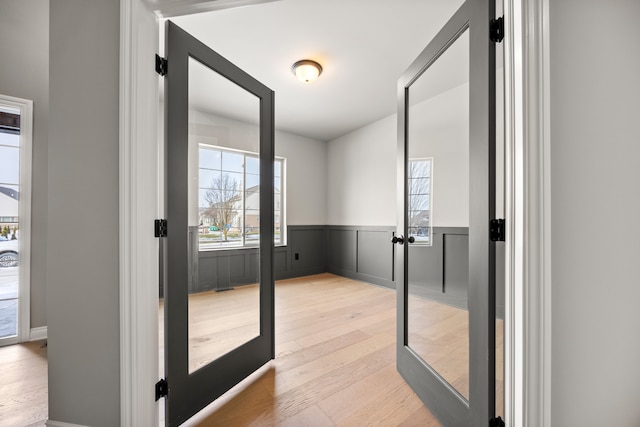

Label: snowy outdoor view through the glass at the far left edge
[0,105,20,339]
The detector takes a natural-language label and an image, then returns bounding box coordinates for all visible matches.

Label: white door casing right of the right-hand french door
[505,0,551,427]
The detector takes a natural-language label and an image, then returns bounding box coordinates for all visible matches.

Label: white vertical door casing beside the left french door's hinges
[119,0,159,427]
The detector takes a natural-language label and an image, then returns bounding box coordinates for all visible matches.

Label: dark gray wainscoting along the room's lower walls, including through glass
[166,225,505,318]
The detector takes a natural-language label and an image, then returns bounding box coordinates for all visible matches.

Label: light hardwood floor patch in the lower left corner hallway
[0,341,48,427]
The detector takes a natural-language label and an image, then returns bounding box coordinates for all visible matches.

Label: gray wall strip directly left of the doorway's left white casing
[47,0,120,427]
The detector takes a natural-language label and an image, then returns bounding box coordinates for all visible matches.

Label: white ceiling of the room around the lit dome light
[171,0,461,141]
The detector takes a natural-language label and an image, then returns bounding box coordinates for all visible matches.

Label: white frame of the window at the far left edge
[0,95,33,346]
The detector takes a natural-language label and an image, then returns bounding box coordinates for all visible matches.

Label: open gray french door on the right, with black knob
[393,0,495,426]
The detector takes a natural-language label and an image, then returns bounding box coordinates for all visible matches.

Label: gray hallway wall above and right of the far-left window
[0,0,49,328]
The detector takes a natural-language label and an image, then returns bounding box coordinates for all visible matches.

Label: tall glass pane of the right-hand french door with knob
[407,30,469,399]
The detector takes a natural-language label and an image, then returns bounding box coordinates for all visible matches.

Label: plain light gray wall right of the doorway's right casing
[549,0,640,427]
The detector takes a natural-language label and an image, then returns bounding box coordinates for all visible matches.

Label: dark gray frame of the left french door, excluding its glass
[162,21,274,426]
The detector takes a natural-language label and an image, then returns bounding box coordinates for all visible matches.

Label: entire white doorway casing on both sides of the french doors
[120,0,551,427]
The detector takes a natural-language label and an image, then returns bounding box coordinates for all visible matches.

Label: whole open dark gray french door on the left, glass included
[163,21,274,426]
